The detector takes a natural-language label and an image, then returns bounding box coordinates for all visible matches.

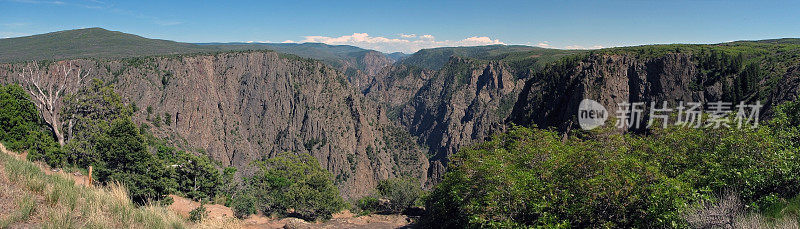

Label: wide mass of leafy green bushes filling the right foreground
[421,96,800,228]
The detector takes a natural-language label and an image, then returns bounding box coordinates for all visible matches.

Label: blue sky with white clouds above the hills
[0,0,800,53]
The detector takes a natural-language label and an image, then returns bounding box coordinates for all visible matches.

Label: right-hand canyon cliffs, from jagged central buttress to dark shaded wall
[366,47,800,186]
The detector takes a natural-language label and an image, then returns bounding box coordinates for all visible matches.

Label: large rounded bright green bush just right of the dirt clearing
[423,128,692,227]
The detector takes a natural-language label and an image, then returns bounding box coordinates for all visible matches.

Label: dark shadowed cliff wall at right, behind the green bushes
[509,53,798,131]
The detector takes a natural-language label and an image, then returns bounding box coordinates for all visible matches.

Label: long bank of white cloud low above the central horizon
[283,33,505,53]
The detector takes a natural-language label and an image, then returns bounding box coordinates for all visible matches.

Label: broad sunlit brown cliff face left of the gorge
[0,52,428,198]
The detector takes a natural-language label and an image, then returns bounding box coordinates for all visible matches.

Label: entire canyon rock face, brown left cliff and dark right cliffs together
[0,48,800,195]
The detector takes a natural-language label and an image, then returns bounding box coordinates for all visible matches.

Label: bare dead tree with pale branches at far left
[19,61,92,146]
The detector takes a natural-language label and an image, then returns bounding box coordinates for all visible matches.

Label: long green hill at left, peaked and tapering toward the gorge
[0,28,395,67]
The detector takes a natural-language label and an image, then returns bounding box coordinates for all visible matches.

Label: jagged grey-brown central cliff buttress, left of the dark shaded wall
[396,57,523,182]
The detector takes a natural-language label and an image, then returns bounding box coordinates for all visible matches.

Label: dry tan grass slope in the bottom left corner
[0,148,186,228]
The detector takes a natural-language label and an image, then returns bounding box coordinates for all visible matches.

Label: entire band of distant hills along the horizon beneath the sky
[0,28,576,72]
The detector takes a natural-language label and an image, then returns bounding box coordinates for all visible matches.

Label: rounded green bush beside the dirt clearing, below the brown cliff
[233,153,345,220]
